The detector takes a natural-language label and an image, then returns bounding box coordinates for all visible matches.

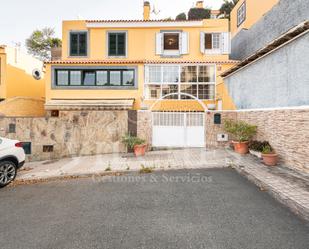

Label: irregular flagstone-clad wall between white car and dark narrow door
[0,111,128,161]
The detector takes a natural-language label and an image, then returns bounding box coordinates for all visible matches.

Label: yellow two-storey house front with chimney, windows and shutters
[46,2,235,111]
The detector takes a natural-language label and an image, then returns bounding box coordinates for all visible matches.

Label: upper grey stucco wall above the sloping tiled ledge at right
[230,0,309,60]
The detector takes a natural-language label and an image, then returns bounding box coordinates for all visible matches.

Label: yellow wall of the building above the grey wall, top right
[231,0,279,36]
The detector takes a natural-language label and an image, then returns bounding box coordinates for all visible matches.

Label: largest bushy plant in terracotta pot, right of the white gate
[224,120,257,154]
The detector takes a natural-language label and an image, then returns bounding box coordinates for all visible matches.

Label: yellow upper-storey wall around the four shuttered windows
[62,19,229,60]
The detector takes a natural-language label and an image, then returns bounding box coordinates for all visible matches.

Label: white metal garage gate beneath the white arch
[152,112,205,147]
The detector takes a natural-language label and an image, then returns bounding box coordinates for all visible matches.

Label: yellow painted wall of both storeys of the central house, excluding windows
[46,19,233,110]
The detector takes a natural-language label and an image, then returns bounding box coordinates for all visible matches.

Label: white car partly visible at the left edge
[0,137,26,188]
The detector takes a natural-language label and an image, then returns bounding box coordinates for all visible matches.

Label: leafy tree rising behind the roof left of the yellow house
[26,28,61,60]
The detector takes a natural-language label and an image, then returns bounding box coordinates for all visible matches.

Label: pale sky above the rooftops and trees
[0,0,223,48]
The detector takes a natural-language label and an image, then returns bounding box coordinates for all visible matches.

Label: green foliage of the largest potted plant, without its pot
[224,119,257,142]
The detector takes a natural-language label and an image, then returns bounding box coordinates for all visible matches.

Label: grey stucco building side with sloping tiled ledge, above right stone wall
[222,0,309,109]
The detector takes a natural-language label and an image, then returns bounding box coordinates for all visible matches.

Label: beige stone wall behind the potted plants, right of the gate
[206,109,309,173]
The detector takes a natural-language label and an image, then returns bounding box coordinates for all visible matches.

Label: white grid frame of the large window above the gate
[144,63,217,101]
